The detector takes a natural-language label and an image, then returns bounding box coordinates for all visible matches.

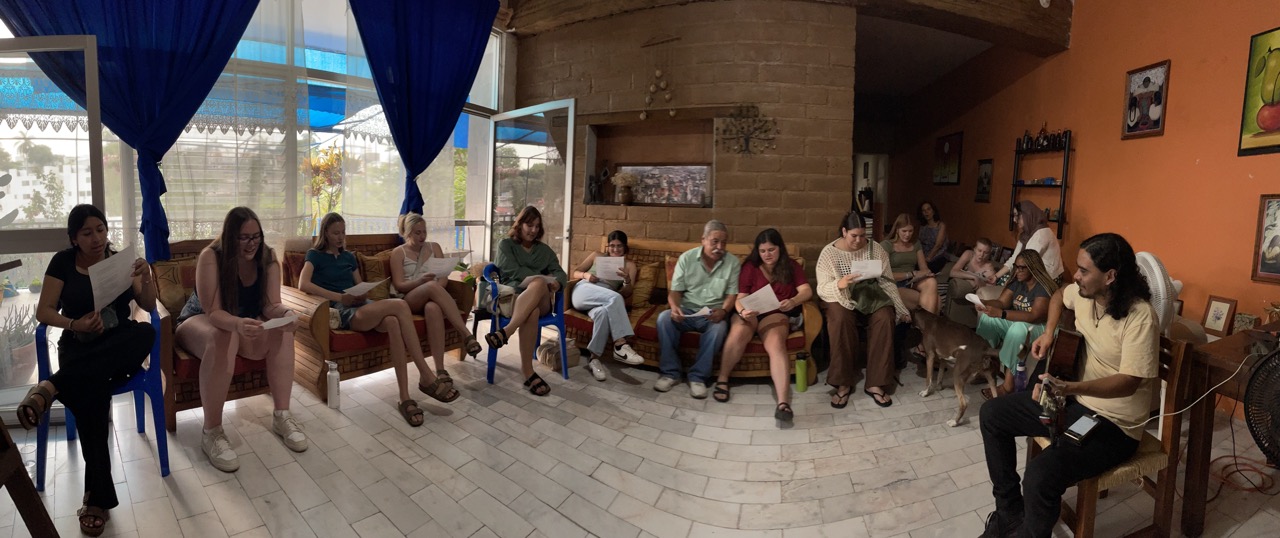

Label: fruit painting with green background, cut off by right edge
[1236,28,1280,156]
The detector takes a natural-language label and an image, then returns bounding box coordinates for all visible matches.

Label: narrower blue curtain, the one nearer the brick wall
[349,0,498,214]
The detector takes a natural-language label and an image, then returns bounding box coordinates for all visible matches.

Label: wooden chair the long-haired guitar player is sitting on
[1027,337,1189,538]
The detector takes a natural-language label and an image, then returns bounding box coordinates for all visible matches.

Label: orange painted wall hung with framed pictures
[890,0,1280,320]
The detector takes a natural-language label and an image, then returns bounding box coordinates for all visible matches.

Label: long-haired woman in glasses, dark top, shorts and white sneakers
[175,208,307,473]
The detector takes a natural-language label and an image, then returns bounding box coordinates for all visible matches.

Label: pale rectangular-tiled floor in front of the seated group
[0,335,1280,538]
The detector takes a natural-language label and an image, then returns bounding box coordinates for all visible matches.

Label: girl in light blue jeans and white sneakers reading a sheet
[571,229,644,380]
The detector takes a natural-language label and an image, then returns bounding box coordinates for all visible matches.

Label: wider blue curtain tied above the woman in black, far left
[0,0,259,261]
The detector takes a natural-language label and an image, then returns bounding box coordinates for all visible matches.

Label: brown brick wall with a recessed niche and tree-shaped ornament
[516,0,856,273]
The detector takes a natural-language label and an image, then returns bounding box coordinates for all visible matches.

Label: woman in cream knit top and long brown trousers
[818,211,911,409]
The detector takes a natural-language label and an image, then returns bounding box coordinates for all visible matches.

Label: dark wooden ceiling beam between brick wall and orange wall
[854,0,1074,56]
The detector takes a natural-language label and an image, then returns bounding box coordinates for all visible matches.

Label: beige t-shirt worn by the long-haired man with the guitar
[1062,284,1160,439]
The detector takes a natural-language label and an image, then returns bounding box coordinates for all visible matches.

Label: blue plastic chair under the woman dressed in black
[36,313,169,492]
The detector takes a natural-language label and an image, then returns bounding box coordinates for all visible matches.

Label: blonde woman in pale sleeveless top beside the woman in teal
[390,213,481,380]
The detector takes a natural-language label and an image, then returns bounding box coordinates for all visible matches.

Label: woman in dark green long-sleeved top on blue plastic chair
[484,205,568,396]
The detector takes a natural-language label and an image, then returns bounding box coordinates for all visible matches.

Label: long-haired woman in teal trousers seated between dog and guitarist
[977,250,1057,398]
